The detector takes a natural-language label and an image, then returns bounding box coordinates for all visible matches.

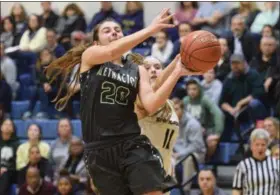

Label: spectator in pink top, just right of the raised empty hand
[174,1,198,24]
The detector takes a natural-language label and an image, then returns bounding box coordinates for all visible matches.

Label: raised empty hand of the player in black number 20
[150,8,175,33]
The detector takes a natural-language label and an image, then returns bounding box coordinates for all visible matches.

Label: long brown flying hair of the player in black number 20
[45,18,117,111]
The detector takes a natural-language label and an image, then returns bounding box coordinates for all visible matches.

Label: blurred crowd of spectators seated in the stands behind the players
[0,2,280,195]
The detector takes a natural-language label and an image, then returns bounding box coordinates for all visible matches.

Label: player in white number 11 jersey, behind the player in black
[135,56,179,175]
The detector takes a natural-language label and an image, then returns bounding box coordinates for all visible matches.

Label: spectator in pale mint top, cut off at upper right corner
[250,2,279,33]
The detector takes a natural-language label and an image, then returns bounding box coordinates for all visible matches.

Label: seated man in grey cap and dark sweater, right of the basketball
[220,54,267,138]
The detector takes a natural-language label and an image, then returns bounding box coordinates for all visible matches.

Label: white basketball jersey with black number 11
[138,101,179,175]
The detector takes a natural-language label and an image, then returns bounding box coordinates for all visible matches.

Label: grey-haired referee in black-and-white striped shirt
[232,129,280,195]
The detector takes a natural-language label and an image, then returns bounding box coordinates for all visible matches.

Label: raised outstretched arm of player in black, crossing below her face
[82,9,175,67]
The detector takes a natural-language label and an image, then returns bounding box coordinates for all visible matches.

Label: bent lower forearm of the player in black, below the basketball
[145,70,181,113]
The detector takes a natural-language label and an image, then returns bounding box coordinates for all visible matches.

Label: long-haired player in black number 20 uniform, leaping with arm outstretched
[47,9,199,195]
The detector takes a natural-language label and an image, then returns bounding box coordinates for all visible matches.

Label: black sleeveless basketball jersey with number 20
[80,62,140,143]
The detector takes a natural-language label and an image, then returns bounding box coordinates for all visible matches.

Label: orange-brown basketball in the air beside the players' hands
[180,30,221,72]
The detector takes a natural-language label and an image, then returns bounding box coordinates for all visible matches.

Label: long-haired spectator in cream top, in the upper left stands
[19,14,47,52]
